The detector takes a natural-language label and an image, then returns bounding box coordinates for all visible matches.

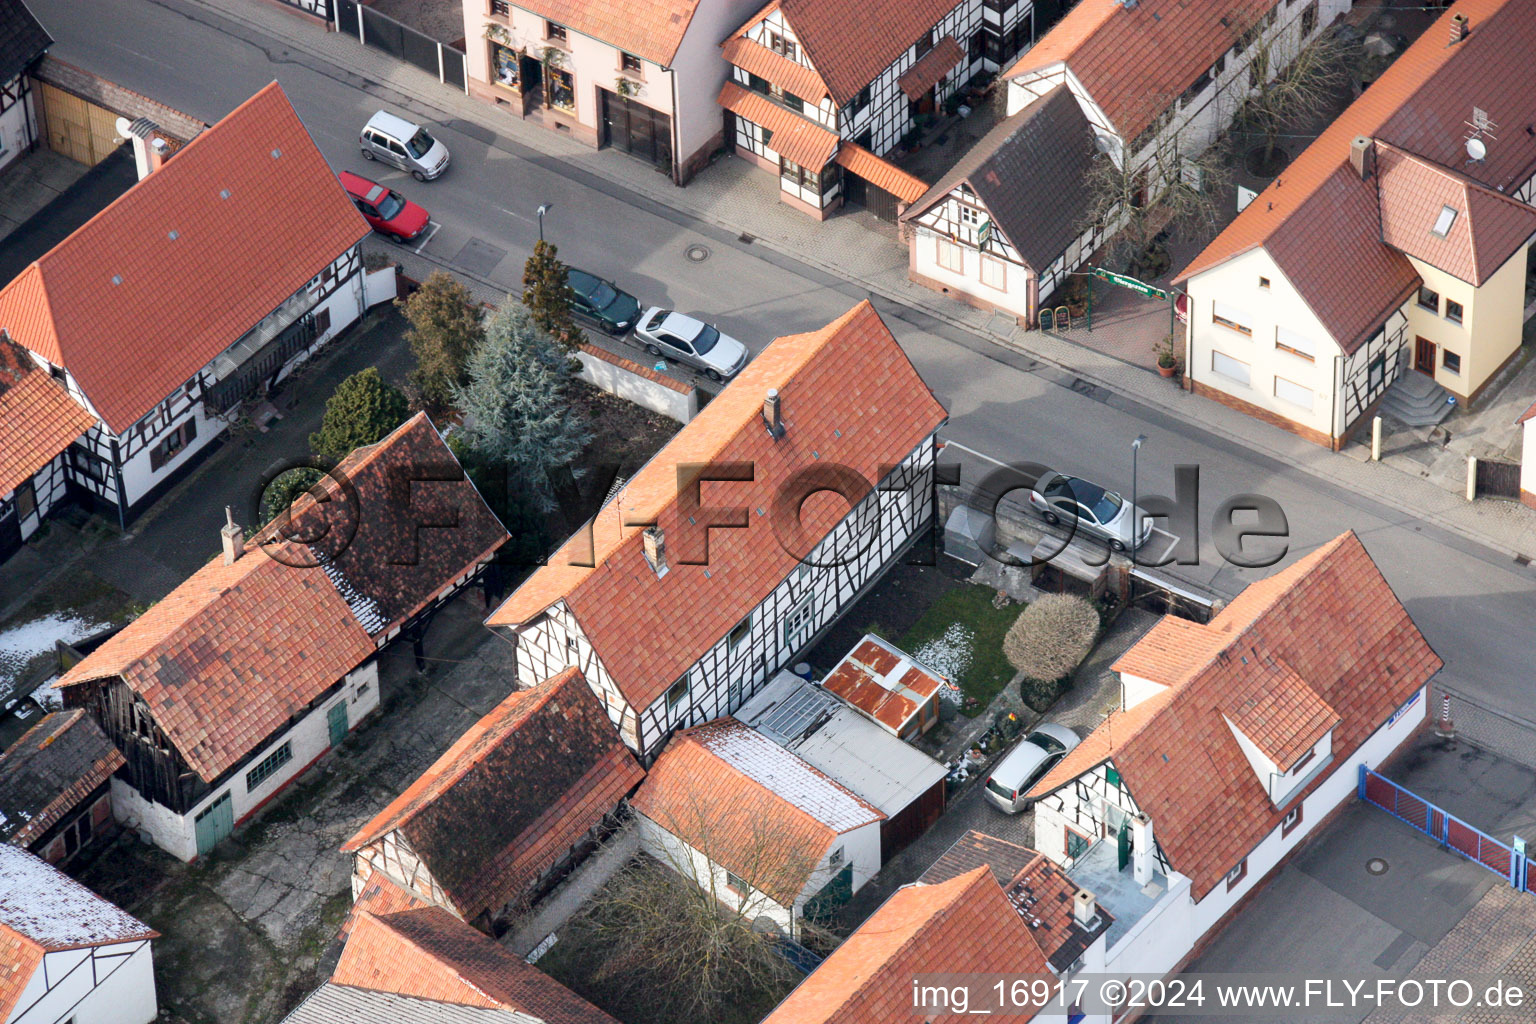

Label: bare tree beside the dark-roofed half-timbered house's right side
[1081,95,1232,278]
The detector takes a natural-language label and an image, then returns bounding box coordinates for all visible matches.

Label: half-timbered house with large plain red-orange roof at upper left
[0,83,369,516]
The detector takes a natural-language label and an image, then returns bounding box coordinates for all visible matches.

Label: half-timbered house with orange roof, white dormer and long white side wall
[1029,533,1441,975]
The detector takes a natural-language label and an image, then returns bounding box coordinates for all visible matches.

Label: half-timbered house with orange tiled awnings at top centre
[720,0,1035,220]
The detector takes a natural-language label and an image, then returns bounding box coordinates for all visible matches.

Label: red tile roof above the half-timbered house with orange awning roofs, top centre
[749,0,960,106]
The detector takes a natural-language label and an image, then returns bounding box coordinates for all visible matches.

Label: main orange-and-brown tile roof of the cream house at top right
[1177,0,1536,352]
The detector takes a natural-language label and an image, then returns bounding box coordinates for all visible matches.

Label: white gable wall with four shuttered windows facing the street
[1184,249,1344,436]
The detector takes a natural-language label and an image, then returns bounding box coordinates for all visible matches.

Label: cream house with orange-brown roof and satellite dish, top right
[1177,0,1536,448]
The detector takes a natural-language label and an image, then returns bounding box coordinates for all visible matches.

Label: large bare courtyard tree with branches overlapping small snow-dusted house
[570,792,825,1024]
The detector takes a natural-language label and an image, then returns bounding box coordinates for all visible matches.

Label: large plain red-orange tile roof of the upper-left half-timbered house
[0,83,369,433]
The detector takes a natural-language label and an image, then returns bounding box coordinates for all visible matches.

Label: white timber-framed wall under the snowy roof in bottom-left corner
[6,941,157,1024]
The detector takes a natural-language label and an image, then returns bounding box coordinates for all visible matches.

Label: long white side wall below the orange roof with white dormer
[1105,688,1428,973]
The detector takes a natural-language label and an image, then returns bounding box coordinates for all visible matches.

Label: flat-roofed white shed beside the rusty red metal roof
[736,672,946,863]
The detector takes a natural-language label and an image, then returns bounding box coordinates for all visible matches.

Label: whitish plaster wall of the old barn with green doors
[112,660,379,861]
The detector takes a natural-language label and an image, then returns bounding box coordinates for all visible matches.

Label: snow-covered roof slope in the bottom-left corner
[0,844,155,949]
